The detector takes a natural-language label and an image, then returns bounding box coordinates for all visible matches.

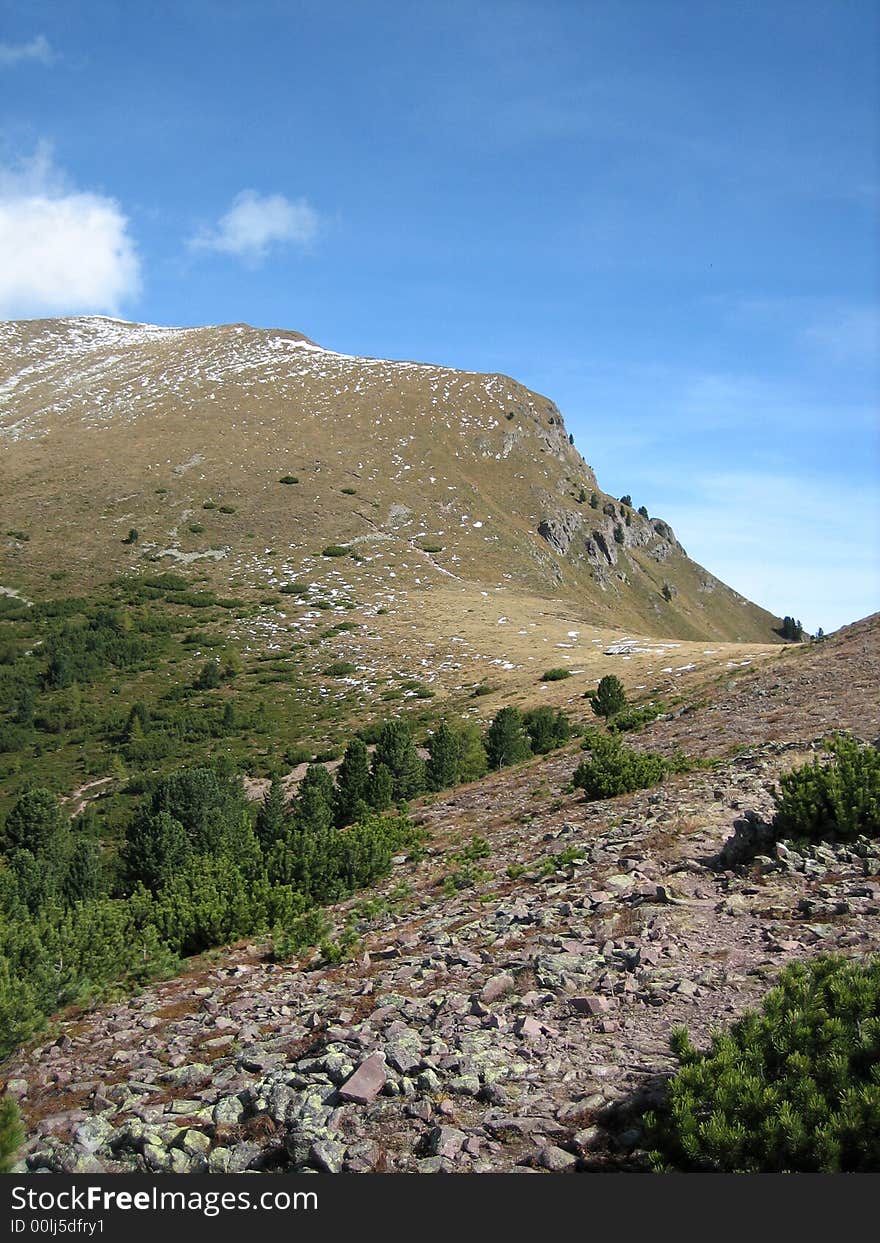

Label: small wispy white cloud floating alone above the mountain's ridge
[190,190,319,260]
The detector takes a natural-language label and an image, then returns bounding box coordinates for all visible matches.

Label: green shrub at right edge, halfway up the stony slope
[773,735,880,839]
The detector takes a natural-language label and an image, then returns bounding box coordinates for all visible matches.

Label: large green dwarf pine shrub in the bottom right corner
[645,956,880,1173]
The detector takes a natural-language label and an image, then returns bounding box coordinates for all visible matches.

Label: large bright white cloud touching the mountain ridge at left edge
[0,144,140,318]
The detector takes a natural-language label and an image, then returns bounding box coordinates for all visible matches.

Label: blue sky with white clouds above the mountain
[0,0,880,630]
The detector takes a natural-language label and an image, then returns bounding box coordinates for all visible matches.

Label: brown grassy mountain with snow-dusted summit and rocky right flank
[0,317,779,641]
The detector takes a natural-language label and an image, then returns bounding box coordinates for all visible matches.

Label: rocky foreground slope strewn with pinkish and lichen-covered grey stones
[5,618,880,1173]
